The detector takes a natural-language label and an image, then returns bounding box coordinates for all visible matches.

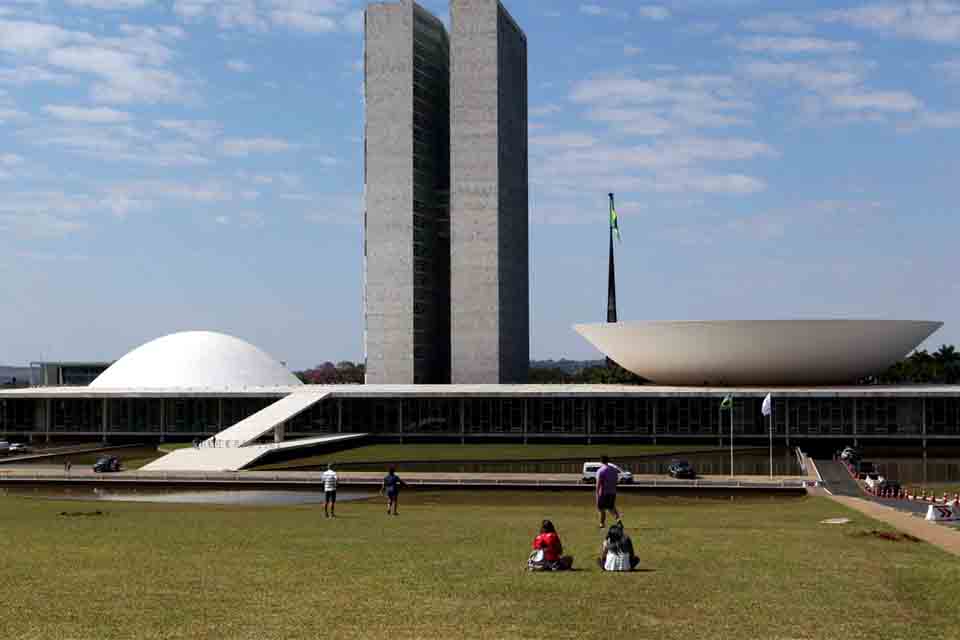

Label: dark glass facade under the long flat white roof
[0,392,960,439]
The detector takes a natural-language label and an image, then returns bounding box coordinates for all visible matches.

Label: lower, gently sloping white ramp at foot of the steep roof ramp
[141,433,367,471]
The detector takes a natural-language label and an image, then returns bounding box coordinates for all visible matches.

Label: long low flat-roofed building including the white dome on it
[0,332,960,444]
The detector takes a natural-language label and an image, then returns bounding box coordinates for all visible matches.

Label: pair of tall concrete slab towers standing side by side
[364,0,530,384]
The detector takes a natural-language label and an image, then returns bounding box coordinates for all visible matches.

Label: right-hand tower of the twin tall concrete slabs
[450,0,529,384]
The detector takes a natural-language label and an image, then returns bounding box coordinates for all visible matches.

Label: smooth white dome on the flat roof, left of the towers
[90,331,302,389]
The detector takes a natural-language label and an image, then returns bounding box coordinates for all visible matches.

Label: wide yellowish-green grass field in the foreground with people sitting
[0,491,960,640]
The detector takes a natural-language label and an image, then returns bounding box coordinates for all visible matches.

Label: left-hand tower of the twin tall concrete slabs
[364,0,450,384]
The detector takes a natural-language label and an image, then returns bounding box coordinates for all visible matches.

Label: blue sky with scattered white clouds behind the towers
[0,0,960,367]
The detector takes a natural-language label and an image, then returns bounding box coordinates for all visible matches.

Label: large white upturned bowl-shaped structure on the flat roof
[574,320,943,386]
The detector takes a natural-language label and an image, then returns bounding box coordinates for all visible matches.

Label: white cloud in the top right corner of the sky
[822,0,960,44]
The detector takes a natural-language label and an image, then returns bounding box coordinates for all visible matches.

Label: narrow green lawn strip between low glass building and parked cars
[253,444,718,469]
